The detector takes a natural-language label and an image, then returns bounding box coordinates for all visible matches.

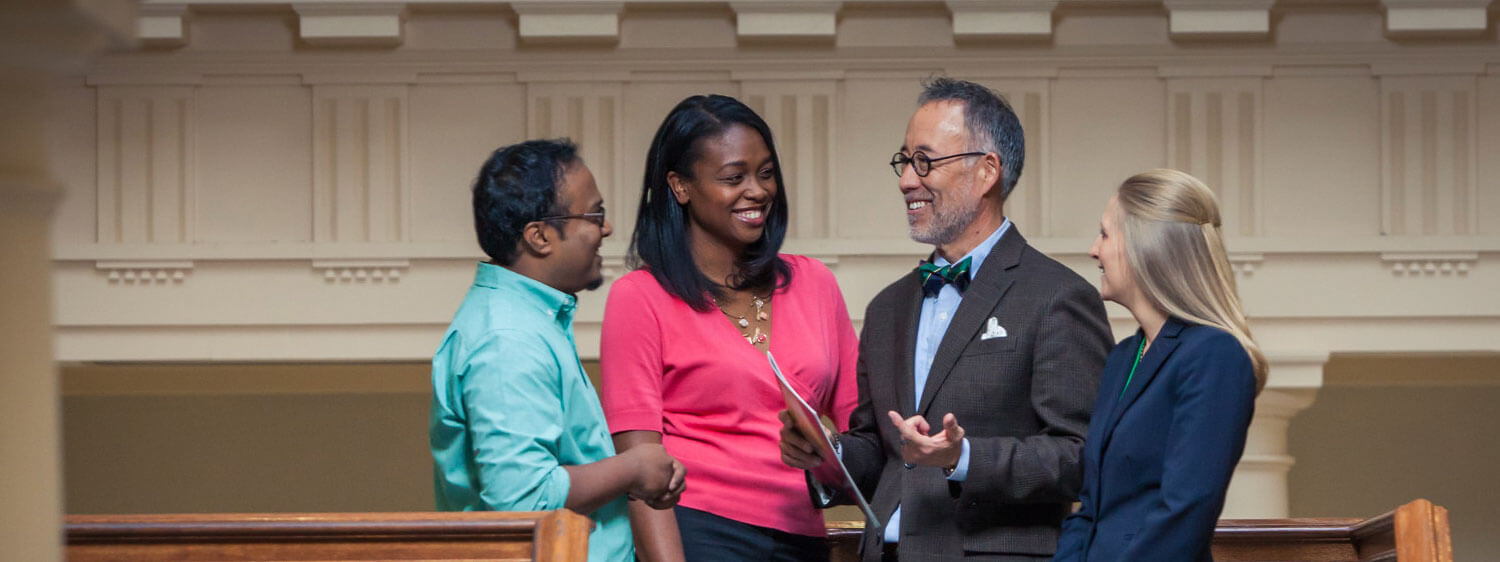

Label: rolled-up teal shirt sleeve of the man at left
[462,330,570,511]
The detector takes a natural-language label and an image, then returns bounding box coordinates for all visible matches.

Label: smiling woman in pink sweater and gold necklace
[602,96,858,562]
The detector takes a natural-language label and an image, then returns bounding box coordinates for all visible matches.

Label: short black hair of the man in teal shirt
[474,138,579,265]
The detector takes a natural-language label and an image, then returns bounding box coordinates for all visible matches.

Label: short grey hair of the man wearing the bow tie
[917,76,1026,201]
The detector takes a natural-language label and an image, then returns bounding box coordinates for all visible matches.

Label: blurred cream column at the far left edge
[0,1,135,562]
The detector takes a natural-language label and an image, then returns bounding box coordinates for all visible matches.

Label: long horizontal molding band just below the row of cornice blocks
[89,43,1500,78]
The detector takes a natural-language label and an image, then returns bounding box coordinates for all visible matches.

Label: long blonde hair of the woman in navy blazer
[1116,169,1266,393]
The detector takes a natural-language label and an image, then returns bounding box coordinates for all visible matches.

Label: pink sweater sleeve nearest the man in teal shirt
[599,274,666,433]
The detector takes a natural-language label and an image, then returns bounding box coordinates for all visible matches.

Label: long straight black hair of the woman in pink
[629,94,792,310]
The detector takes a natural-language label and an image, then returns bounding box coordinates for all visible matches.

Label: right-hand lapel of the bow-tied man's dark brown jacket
[912,223,1026,415]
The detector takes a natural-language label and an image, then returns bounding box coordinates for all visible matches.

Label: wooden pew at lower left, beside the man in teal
[66,510,593,562]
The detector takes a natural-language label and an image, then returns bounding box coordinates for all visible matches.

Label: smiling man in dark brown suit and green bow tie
[782,78,1113,561]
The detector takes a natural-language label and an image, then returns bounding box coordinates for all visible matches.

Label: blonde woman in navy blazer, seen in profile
[1055,169,1266,561]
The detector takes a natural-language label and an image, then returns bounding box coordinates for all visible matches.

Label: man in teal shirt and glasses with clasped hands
[429,139,684,561]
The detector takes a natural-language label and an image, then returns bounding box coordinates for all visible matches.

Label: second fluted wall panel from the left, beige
[312,85,410,243]
